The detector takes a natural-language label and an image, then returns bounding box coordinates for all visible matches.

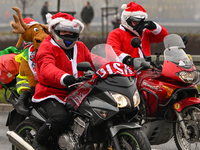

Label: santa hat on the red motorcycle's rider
[121,2,148,19]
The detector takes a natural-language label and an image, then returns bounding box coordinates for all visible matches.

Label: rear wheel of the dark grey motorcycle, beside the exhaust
[12,119,41,150]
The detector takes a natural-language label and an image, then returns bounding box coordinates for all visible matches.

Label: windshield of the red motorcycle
[164,34,192,68]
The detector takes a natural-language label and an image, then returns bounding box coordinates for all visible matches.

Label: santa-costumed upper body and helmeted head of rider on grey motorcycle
[32,13,91,103]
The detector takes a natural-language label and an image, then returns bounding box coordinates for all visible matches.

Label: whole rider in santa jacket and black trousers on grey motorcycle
[32,12,95,150]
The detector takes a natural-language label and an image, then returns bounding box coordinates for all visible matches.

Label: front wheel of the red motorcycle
[173,106,200,150]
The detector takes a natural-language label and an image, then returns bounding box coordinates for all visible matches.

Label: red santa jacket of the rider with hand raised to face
[107,24,168,61]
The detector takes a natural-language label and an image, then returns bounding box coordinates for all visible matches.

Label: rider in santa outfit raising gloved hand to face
[107,2,168,65]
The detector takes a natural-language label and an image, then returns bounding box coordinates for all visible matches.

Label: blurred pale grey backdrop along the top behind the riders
[0,0,200,24]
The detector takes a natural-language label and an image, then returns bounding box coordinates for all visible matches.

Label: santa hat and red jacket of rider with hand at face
[107,2,168,61]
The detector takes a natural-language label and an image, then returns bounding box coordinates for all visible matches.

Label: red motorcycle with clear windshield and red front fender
[131,34,200,150]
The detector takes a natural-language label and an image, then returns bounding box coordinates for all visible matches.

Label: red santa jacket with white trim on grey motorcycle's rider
[32,36,92,103]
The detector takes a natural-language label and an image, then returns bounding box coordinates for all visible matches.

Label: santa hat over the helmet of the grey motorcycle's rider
[46,12,84,33]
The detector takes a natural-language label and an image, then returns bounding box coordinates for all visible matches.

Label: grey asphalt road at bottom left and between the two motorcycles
[0,112,177,150]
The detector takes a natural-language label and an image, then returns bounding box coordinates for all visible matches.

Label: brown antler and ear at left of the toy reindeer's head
[11,7,29,47]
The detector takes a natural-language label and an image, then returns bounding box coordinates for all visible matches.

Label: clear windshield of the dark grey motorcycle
[91,44,121,70]
